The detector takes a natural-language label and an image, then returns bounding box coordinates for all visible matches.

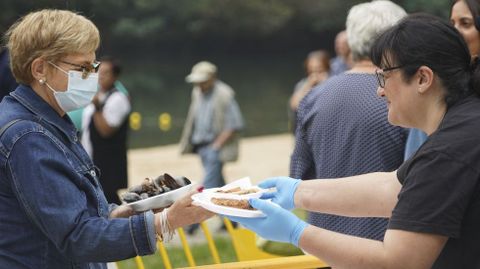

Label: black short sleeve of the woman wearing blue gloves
[389,151,478,238]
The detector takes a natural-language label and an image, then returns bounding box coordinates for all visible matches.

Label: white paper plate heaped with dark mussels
[127,183,195,212]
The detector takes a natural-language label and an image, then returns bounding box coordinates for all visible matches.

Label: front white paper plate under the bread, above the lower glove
[192,192,265,218]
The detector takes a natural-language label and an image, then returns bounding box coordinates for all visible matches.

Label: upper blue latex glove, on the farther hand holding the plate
[258,177,301,210]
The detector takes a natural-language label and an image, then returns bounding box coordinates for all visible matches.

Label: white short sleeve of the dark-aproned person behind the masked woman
[103,92,131,128]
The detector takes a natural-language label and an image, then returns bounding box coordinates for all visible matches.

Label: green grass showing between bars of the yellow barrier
[118,237,237,269]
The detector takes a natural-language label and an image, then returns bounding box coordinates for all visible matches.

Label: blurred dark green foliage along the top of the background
[0,0,450,49]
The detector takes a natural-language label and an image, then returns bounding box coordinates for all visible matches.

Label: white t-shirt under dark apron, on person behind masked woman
[81,91,132,157]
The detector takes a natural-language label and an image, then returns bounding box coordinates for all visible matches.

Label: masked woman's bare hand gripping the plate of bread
[167,188,215,229]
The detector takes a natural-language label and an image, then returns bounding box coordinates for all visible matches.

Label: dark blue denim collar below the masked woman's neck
[10,84,78,143]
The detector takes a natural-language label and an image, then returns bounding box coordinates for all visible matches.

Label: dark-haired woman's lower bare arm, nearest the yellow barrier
[299,226,448,269]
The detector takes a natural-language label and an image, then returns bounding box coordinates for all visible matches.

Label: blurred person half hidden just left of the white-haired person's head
[330,30,351,76]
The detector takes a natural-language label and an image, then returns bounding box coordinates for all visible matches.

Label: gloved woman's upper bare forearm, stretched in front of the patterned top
[294,171,401,217]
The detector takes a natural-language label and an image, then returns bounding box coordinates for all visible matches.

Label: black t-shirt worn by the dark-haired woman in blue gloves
[388,97,480,269]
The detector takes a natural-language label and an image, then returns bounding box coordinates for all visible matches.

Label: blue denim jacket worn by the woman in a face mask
[0,85,156,269]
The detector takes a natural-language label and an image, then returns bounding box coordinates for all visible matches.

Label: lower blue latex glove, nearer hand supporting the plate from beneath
[227,199,308,246]
